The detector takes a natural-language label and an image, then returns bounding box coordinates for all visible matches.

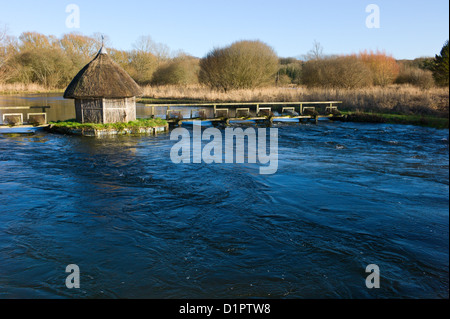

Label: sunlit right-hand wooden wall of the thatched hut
[103,97,136,123]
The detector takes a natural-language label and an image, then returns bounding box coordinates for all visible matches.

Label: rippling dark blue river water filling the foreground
[0,95,449,298]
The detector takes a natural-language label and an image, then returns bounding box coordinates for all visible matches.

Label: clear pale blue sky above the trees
[0,0,449,59]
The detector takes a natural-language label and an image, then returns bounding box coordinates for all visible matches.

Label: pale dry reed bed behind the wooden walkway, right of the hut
[144,85,449,116]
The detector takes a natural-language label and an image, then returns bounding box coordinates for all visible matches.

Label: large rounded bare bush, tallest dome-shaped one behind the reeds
[199,41,278,91]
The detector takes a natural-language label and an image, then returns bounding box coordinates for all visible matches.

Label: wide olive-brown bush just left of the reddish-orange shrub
[302,55,372,89]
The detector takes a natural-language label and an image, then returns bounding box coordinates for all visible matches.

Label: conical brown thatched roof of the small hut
[64,48,142,99]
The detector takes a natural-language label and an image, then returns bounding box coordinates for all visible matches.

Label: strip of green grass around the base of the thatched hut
[49,118,167,131]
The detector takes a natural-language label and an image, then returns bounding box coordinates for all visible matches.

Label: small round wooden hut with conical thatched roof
[64,47,142,123]
